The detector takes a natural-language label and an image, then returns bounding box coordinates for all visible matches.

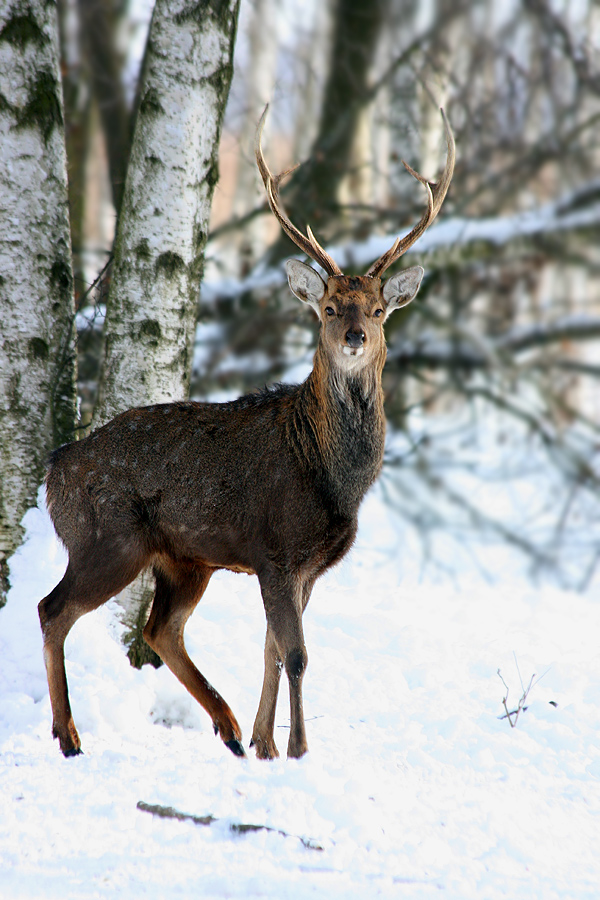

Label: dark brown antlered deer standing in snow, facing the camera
[38,107,455,759]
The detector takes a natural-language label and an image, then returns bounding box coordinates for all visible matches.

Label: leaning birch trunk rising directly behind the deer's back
[94,0,239,665]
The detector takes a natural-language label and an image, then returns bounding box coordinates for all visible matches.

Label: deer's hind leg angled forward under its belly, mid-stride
[144,562,246,756]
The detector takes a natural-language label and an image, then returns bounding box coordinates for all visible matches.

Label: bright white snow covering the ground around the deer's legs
[0,487,600,900]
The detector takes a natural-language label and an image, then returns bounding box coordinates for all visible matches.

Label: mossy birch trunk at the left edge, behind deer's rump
[0,0,76,604]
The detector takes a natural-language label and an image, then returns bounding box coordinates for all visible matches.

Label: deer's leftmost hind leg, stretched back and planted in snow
[38,550,143,756]
